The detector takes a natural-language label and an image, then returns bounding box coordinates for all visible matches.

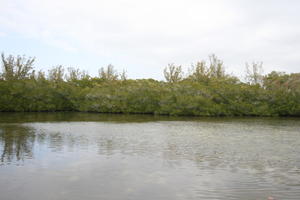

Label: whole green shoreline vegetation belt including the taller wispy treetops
[0,54,300,116]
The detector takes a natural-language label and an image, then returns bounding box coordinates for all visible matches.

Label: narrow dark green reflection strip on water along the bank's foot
[0,112,299,124]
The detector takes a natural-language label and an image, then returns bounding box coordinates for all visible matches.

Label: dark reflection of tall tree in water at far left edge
[0,124,35,163]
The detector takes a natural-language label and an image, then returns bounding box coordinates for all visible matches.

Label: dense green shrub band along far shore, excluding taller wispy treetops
[0,79,300,117]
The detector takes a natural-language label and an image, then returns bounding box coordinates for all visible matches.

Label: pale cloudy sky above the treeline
[0,0,300,80]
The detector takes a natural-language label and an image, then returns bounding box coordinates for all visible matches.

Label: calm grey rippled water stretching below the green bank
[0,113,300,200]
